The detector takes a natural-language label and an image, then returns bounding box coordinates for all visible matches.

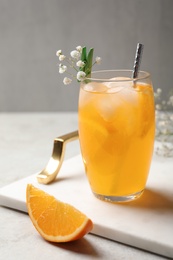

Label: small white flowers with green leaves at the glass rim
[56,46,101,85]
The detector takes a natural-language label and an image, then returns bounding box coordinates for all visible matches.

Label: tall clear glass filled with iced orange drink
[78,70,155,202]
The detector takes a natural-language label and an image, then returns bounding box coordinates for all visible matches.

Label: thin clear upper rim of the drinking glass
[85,69,151,82]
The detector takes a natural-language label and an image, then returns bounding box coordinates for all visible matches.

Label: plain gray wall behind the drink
[0,0,173,112]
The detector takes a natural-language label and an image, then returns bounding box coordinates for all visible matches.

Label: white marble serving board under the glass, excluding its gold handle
[0,155,173,257]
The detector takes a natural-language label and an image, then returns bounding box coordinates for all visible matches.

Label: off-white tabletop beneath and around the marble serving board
[0,113,170,260]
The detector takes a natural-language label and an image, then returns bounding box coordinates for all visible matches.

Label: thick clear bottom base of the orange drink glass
[93,190,144,203]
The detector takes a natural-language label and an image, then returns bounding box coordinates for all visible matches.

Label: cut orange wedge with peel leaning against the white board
[26,184,93,242]
